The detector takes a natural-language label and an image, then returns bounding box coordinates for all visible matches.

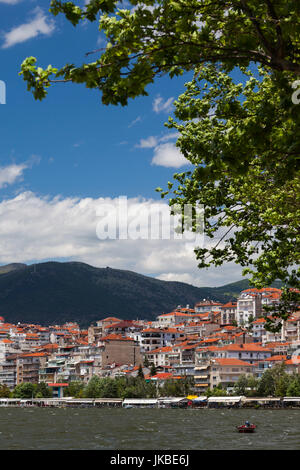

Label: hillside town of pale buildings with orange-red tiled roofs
[0,288,300,406]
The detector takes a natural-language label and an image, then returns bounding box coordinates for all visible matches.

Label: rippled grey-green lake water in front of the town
[0,408,300,450]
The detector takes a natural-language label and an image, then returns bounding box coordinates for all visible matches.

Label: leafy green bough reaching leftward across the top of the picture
[22,0,300,105]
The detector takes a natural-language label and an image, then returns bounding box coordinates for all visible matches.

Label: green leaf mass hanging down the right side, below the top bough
[160,65,300,329]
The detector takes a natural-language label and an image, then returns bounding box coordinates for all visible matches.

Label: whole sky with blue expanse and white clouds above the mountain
[0,0,245,286]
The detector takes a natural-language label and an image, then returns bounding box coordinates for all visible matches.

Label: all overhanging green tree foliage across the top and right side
[21,0,300,329]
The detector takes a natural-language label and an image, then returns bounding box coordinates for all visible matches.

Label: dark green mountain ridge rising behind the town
[0,262,282,327]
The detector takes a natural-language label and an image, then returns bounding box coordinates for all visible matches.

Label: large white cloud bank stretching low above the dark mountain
[0,192,240,286]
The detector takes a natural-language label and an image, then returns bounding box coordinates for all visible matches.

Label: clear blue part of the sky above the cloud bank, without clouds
[0,0,190,198]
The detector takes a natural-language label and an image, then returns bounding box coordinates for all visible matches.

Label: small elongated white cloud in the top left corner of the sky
[2,7,55,49]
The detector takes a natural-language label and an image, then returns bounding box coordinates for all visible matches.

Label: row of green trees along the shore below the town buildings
[0,364,300,399]
